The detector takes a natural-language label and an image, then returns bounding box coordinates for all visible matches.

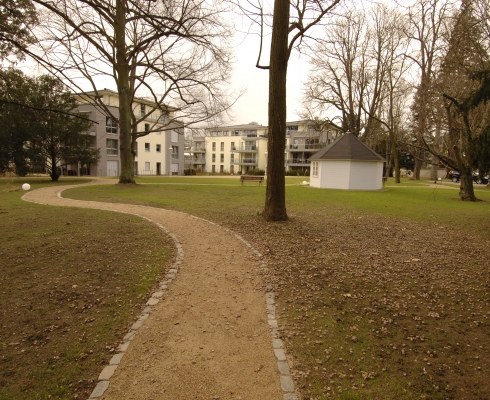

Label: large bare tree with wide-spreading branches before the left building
[31,0,235,183]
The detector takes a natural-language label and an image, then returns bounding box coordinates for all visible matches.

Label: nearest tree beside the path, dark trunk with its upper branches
[239,0,340,221]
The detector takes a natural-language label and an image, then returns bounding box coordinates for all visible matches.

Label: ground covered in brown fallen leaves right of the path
[221,207,490,399]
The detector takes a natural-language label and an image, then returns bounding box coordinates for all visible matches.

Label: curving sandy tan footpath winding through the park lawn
[23,180,297,400]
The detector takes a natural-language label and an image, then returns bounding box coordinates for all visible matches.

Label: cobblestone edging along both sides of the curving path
[22,182,298,400]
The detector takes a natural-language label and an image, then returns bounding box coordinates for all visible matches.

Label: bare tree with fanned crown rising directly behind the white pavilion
[303,10,370,136]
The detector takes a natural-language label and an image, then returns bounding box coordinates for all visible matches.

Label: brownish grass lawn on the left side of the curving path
[0,178,173,400]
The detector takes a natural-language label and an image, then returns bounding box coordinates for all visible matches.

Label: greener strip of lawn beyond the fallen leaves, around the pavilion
[65,177,490,237]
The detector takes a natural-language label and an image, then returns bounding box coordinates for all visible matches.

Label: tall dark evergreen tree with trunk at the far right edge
[423,1,490,201]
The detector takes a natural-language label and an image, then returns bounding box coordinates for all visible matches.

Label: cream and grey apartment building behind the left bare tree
[74,89,184,176]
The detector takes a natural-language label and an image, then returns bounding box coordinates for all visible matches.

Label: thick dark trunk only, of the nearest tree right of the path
[262,0,289,221]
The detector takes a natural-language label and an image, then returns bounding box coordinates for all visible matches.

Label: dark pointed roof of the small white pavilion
[310,132,385,161]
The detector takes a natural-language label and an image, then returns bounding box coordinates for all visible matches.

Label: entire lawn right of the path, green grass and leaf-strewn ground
[65,178,490,399]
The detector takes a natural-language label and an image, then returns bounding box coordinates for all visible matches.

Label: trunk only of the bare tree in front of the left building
[114,0,134,183]
